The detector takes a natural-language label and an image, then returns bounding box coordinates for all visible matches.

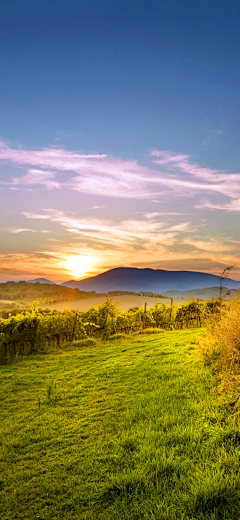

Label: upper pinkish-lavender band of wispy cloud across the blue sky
[0,142,240,211]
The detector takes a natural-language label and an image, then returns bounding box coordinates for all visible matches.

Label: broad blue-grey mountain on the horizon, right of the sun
[61,267,238,294]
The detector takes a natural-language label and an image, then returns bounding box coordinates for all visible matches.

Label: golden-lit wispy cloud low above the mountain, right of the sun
[21,210,238,278]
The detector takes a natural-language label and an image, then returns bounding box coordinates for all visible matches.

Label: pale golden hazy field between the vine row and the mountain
[43,294,189,312]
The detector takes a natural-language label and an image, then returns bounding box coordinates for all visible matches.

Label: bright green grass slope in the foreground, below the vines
[0,330,240,520]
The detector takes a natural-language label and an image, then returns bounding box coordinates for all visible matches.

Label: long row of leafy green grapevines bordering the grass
[0,299,223,363]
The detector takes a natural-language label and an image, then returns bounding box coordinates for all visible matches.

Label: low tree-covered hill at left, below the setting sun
[0,282,96,304]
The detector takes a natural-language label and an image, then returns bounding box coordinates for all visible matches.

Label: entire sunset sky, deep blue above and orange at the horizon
[0,0,240,282]
